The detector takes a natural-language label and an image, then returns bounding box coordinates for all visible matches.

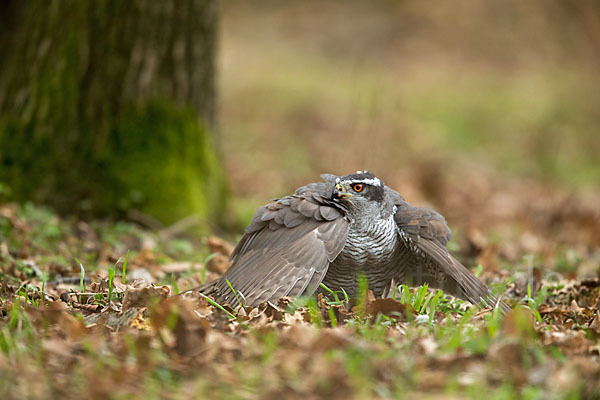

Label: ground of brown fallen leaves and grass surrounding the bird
[0,163,600,399]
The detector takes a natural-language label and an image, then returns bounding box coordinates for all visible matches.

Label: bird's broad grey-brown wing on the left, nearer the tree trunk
[205,183,349,306]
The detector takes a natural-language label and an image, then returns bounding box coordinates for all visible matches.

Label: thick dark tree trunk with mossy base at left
[0,0,226,222]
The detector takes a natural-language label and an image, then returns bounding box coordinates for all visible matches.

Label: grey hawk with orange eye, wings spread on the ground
[198,171,509,311]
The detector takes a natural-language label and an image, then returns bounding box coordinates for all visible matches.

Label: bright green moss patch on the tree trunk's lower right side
[104,102,227,222]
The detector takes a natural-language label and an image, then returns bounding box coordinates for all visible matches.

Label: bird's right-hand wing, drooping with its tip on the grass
[387,189,509,311]
